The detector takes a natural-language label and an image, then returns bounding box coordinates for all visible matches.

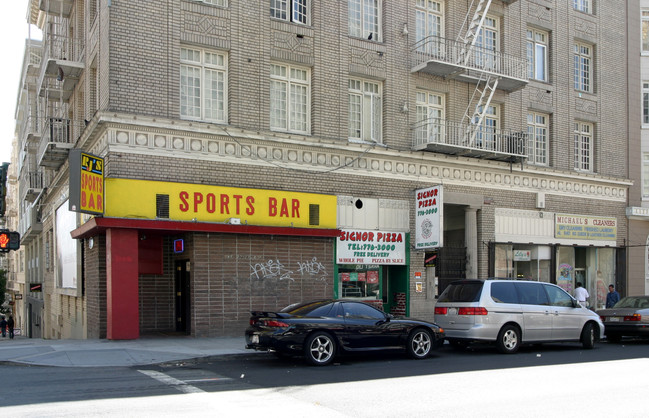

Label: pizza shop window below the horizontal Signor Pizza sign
[338,265,381,299]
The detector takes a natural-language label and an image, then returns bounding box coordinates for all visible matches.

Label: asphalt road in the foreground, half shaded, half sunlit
[0,341,649,417]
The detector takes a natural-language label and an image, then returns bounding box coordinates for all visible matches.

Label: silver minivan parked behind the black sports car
[435,279,604,353]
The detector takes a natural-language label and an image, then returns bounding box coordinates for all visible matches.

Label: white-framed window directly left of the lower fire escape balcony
[349,79,383,143]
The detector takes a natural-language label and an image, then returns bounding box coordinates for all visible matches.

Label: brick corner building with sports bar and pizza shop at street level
[6,0,632,339]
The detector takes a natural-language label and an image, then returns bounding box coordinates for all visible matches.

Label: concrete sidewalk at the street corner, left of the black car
[0,336,255,367]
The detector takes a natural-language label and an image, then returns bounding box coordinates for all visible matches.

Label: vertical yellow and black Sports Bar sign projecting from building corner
[69,149,104,215]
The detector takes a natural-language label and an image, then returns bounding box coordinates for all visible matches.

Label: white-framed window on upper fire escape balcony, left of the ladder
[415,0,444,55]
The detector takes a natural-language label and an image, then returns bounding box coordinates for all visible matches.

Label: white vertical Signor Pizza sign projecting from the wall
[415,186,444,250]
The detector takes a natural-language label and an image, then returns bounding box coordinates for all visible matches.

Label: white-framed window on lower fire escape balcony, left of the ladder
[415,91,446,144]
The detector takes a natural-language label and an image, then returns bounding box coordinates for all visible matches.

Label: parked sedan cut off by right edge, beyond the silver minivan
[597,296,649,342]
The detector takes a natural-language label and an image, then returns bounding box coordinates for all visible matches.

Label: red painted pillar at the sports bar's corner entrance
[106,228,140,340]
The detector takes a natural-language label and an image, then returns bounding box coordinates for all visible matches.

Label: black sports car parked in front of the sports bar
[246,300,444,366]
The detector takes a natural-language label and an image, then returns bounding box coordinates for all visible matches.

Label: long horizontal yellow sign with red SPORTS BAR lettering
[104,178,337,229]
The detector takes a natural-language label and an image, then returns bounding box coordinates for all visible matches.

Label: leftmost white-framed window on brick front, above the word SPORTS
[180,47,228,123]
